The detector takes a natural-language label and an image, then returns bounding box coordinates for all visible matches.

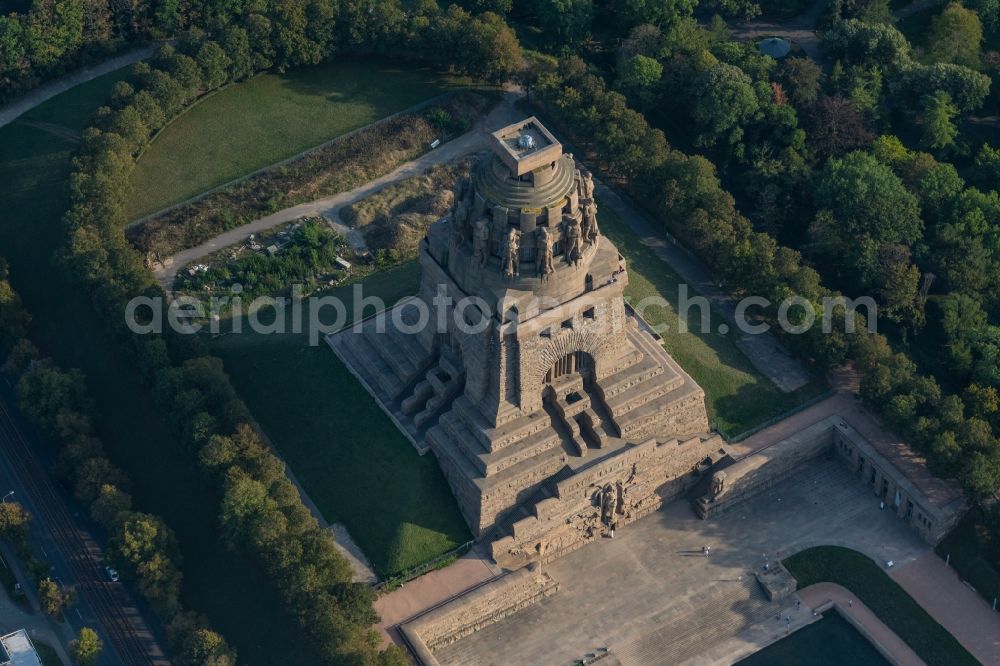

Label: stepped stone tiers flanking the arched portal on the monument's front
[430,320,702,524]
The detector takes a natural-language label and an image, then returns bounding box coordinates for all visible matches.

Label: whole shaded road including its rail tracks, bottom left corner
[0,396,170,666]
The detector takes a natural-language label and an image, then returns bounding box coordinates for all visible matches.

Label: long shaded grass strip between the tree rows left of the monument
[0,72,326,664]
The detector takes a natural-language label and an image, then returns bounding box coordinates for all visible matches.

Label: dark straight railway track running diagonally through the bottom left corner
[0,399,154,666]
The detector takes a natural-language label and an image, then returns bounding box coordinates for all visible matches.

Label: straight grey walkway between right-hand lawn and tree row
[595,179,812,392]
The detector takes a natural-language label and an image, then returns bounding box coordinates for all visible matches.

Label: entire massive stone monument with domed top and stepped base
[330,118,723,567]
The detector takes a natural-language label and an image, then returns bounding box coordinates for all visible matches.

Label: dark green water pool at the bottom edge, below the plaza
[737,612,889,666]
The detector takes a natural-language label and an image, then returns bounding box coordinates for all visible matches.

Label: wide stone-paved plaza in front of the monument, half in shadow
[435,459,930,666]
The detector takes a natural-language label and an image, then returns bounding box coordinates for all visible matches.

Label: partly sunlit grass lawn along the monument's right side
[598,202,826,436]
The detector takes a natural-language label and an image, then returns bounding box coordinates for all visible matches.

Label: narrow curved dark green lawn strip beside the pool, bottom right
[784,546,979,666]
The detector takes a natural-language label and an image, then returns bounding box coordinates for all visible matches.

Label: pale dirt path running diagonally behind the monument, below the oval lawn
[154,91,523,288]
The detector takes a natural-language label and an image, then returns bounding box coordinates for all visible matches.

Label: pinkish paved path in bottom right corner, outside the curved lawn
[889,553,1000,666]
